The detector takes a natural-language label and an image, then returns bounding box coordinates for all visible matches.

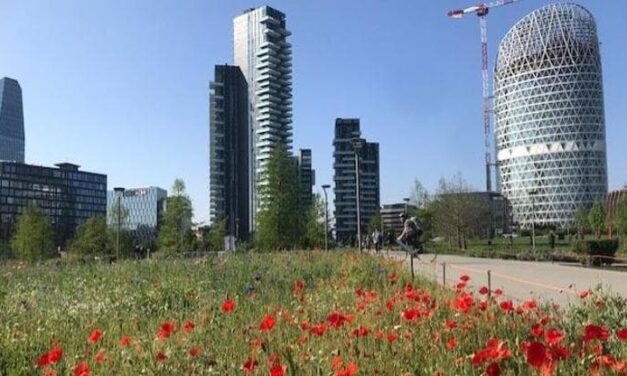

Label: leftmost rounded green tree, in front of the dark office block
[11,203,55,261]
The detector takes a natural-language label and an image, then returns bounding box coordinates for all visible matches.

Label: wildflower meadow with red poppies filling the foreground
[0,252,627,375]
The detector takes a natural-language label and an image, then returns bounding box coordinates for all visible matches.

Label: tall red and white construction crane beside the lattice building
[448,0,521,192]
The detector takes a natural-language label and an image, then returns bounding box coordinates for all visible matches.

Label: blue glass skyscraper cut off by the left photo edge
[0,77,24,163]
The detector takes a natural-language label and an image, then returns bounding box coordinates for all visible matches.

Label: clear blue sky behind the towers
[0,0,627,221]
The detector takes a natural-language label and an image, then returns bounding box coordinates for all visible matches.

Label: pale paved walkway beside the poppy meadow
[382,252,627,306]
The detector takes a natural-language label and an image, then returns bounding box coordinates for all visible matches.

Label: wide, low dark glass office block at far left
[0,161,107,246]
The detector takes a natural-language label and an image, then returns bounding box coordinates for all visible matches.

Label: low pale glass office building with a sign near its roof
[107,187,168,244]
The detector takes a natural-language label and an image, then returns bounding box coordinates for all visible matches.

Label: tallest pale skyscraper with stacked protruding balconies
[233,6,292,228]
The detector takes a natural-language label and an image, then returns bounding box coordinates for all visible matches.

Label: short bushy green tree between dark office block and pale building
[69,216,112,255]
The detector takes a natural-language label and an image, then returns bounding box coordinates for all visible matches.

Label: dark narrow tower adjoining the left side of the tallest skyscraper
[209,65,252,239]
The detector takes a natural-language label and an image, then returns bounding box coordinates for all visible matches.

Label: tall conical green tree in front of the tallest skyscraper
[256,144,304,250]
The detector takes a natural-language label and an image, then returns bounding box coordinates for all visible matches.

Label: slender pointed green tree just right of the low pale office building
[157,179,193,253]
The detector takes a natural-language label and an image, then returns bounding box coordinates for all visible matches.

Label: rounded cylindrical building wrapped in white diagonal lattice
[494,3,607,228]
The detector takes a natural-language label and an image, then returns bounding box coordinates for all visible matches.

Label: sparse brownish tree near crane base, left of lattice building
[433,174,486,249]
